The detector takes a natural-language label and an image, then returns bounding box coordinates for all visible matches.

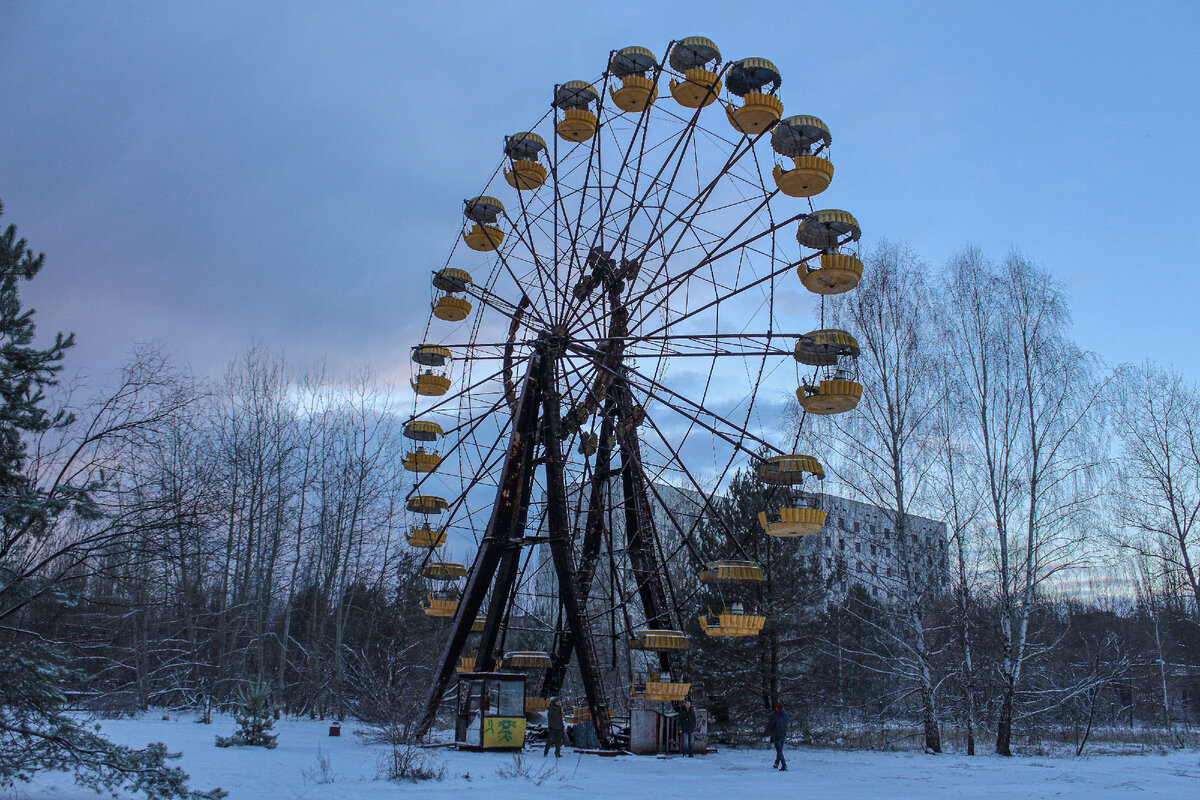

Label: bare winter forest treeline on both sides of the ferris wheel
[0,232,1200,753]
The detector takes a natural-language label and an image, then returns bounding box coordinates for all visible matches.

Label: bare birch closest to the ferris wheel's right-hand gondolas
[832,242,946,752]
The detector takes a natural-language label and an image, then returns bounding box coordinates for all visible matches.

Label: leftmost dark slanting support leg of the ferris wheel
[416,357,541,738]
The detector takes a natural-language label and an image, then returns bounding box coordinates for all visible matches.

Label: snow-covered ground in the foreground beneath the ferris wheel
[21,715,1200,800]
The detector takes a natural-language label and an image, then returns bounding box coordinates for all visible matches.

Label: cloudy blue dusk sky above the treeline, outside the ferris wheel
[0,0,1200,388]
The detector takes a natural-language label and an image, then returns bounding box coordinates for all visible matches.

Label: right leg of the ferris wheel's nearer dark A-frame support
[542,350,612,748]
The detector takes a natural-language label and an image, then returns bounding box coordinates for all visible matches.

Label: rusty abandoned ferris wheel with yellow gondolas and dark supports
[404,36,863,745]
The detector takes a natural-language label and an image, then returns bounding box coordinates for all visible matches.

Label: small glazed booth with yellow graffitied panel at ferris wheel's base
[455,672,526,750]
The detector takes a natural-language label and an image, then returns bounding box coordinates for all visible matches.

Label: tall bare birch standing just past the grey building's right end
[941,249,1106,756]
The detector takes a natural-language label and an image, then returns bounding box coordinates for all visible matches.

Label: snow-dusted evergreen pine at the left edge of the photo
[0,206,224,800]
